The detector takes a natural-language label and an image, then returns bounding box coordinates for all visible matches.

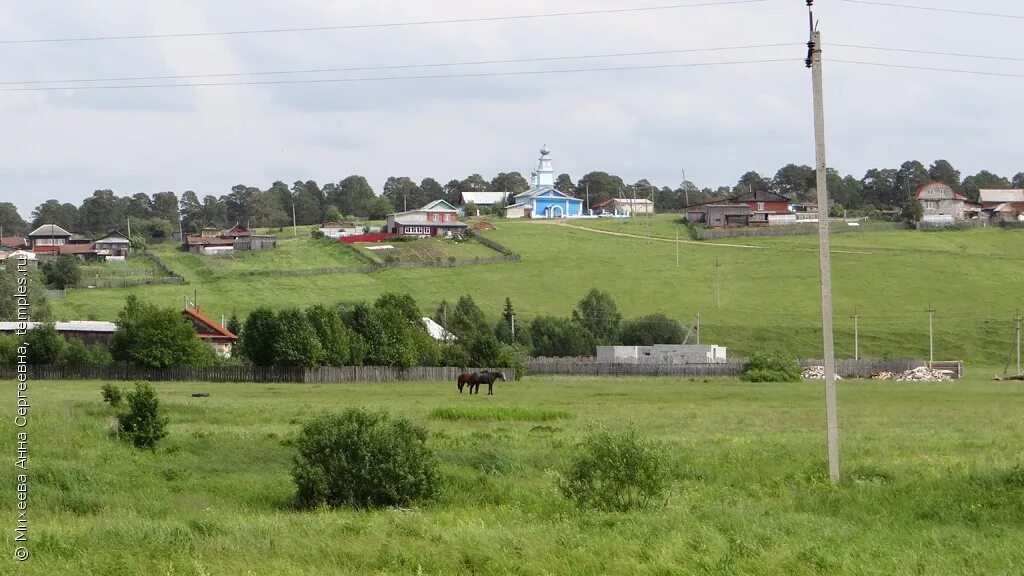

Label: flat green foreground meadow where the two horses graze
[0,378,1024,576]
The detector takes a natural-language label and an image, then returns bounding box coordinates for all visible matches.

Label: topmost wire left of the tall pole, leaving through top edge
[0,0,768,44]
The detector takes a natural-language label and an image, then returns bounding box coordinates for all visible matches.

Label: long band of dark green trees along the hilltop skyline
[0,160,1024,239]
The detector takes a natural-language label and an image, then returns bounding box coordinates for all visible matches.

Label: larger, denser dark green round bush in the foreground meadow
[292,408,439,508]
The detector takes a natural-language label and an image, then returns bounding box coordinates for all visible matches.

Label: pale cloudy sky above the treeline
[0,0,1024,220]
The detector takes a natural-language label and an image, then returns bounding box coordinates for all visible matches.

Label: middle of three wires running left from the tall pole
[0,42,803,85]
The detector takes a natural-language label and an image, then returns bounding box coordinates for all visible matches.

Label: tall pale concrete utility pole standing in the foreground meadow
[805,0,840,484]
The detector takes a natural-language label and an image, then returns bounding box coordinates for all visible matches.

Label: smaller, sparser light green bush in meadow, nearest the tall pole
[558,427,669,511]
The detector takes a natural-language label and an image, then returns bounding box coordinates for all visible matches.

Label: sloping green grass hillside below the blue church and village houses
[52,217,1024,366]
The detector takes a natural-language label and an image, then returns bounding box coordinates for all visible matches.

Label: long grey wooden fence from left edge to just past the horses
[0,364,515,383]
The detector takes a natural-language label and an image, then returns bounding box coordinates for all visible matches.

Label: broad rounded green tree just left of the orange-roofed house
[111,294,214,368]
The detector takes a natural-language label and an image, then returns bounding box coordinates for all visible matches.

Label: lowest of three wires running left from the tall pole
[0,58,800,92]
